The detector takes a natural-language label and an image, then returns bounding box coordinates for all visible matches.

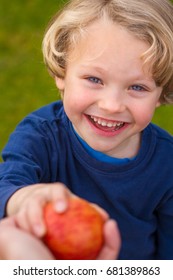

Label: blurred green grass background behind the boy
[0,0,173,160]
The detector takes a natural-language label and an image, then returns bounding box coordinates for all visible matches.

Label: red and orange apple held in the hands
[43,197,104,260]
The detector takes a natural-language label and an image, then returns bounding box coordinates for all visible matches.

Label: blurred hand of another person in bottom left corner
[0,216,54,260]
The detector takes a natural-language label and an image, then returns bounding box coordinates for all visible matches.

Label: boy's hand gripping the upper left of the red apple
[8,183,72,237]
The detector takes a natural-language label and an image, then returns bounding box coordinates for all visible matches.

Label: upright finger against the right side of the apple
[97,220,121,260]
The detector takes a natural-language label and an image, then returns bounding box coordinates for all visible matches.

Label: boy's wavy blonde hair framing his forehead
[43,0,173,104]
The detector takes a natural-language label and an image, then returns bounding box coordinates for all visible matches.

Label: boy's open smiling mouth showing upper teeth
[87,115,125,132]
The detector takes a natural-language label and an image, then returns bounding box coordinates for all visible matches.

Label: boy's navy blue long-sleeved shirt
[0,101,173,260]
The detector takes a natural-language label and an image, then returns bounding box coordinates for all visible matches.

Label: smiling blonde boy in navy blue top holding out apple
[0,0,173,259]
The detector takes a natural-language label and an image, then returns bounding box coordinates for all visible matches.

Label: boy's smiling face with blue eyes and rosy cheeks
[56,20,162,158]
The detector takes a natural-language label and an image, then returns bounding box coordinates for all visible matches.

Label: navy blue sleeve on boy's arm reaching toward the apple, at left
[0,117,53,218]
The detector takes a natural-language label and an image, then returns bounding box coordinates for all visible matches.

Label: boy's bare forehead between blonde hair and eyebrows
[69,19,149,75]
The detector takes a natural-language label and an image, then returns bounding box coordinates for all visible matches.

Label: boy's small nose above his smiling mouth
[98,89,126,113]
